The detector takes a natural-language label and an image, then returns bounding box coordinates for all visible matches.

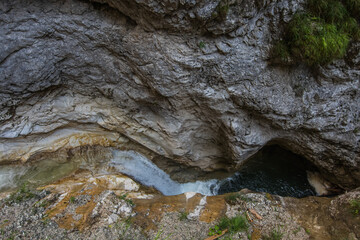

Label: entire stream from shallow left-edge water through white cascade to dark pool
[0,148,314,197]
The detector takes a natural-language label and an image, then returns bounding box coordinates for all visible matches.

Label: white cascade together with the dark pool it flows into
[111,147,315,197]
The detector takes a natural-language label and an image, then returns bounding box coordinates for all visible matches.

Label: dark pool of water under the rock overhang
[218,146,315,197]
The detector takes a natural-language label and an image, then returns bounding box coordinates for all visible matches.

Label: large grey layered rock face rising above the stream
[0,0,360,188]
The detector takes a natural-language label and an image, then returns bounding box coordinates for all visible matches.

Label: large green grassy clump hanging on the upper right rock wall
[270,0,360,66]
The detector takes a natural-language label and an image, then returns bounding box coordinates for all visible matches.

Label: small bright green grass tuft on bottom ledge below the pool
[209,215,249,236]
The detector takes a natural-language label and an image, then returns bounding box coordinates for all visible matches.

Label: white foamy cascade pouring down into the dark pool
[110,150,219,196]
